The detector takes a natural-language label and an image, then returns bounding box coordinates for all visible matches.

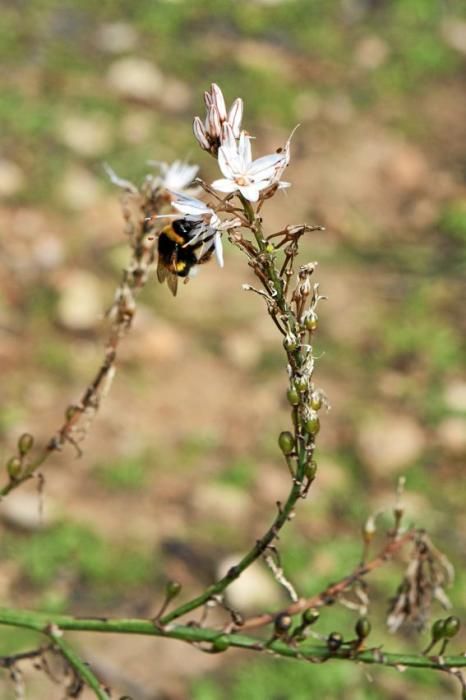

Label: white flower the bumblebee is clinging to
[170,191,240,267]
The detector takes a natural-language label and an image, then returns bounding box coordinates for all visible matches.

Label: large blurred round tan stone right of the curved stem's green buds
[357,415,425,476]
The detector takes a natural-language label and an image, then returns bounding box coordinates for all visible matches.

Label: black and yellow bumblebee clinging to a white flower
[157,219,214,296]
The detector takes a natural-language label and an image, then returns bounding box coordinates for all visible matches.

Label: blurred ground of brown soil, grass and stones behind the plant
[0,0,466,700]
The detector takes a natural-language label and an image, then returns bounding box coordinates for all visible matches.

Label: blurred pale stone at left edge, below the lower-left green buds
[0,490,57,532]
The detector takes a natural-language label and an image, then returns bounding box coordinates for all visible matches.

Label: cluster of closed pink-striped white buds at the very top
[193,83,243,155]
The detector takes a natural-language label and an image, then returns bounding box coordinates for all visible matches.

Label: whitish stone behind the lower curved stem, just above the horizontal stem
[218,554,283,613]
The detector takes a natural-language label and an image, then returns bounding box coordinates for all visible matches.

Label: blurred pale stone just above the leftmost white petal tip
[58,116,112,157]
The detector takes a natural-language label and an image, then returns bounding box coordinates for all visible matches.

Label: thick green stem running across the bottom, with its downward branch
[0,608,466,676]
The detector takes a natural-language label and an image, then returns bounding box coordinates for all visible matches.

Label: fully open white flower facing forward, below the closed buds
[212,124,294,202]
